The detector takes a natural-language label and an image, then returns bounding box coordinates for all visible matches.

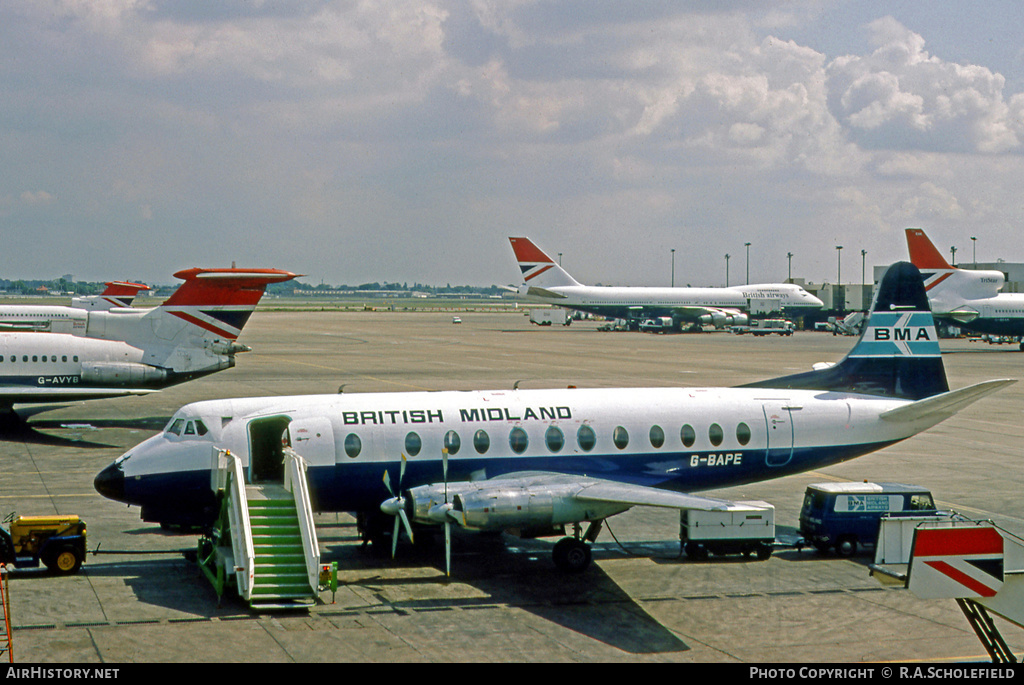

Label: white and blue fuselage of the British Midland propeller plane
[97,388,925,521]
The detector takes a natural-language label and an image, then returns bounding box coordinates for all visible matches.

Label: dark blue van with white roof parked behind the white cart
[800,481,936,557]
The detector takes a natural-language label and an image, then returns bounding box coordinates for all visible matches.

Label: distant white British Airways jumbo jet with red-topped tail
[509,238,823,330]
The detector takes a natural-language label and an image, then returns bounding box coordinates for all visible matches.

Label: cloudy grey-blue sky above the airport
[0,0,1024,285]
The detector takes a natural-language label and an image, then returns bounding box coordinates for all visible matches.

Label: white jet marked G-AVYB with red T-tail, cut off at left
[0,268,295,416]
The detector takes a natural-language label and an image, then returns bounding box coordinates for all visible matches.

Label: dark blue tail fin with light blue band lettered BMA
[742,262,949,399]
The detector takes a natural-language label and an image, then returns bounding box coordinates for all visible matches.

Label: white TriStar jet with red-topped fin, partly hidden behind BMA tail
[906,228,1024,350]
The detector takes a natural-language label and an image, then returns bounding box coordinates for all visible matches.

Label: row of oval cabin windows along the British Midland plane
[345,422,752,459]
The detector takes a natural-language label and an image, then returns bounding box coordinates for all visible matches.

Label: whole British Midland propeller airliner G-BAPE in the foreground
[95,263,1013,569]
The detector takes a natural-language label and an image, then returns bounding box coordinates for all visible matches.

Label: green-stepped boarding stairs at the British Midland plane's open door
[199,448,319,610]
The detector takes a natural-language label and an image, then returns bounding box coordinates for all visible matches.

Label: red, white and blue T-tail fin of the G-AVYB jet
[155,267,298,341]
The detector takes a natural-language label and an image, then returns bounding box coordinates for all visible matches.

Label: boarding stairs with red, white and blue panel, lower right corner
[871,515,1024,663]
